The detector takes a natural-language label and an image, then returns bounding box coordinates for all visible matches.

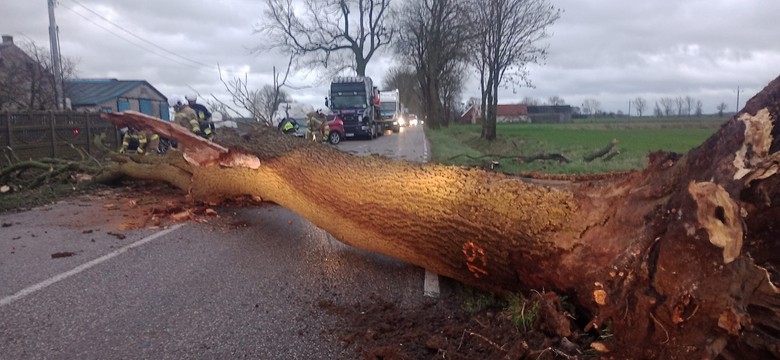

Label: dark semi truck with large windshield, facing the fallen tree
[325,76,382,139]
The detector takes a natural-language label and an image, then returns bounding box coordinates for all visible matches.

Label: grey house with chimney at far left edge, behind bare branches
[0,35,57,110]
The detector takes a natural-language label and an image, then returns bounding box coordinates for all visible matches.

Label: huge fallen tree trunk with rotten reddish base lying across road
[101,74,780,358]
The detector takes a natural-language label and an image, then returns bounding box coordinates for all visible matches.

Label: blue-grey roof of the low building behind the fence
[65,79,168,106]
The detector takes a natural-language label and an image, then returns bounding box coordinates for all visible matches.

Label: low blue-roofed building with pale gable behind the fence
[65,79,170,120]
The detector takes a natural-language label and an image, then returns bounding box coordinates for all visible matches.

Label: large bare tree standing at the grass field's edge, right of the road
[469,0,561,140]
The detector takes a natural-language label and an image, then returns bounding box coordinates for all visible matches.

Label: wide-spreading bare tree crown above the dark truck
[256,0,394,76]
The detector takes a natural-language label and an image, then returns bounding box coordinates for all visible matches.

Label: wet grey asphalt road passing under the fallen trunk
[0,124,438,359]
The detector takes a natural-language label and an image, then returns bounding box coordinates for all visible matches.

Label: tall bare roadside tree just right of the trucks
[395,0,470,129]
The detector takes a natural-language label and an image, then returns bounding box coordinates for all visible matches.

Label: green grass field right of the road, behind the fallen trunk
[426,117,727,174]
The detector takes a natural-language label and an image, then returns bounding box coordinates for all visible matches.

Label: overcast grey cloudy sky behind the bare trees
[0,0,780,113]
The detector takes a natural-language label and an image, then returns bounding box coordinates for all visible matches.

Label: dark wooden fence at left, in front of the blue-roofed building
[0,111,120,162]
